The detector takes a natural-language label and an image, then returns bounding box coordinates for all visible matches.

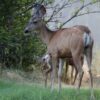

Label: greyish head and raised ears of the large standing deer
[25,3,46,33]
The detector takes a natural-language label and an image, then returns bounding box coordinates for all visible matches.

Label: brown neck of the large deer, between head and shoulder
[40,23,55,45]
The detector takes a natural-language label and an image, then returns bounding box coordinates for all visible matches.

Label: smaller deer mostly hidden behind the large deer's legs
[42,54,79,87]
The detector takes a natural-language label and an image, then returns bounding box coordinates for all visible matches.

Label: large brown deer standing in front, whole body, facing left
[25,3,93,97]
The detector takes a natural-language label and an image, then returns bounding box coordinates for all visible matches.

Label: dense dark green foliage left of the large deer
[0,0,45,68]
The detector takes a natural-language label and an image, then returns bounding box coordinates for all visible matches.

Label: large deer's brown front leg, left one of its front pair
[51,57,57,91]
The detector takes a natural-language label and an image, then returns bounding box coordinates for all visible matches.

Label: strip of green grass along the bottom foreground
[0,80,100,100]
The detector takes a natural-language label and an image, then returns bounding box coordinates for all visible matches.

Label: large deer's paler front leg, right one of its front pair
[58,59,64,92]
